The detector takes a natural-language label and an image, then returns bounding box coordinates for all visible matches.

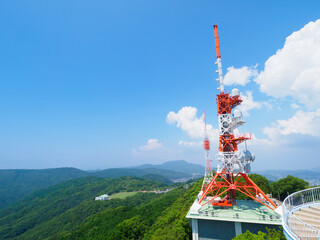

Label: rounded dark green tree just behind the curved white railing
[271,175,309,200]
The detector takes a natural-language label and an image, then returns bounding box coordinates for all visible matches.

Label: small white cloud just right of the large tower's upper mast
[223,66,258,86]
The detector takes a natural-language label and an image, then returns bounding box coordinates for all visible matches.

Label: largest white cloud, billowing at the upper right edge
[255,20,320,108]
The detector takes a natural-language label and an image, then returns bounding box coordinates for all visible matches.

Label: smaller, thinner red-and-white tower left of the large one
[201,112,213,191]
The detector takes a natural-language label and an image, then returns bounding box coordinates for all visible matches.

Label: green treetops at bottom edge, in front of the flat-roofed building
[233,227,286,240]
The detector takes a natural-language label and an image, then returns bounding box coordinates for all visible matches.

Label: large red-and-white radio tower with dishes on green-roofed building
[199,25,277,210]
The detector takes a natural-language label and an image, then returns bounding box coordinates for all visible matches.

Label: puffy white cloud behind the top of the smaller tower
[167,107,218,139]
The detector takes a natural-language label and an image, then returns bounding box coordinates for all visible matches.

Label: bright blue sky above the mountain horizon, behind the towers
[0,0,320,170]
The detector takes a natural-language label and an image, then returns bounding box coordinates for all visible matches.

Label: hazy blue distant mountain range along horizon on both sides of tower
[0,160,320,209]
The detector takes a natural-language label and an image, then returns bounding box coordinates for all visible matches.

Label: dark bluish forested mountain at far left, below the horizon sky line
[0,168,88,208]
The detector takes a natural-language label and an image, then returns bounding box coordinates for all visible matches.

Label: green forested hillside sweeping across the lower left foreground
[0,174,200,239]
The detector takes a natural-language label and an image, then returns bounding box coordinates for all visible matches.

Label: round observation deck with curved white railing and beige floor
[282,187,320,240]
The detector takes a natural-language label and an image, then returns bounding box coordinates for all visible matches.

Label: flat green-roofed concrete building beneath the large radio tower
[187,199,282,240]
